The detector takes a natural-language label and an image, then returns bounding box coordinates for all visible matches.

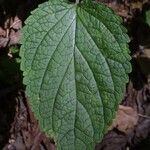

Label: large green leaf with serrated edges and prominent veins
[20,0,131,150]
